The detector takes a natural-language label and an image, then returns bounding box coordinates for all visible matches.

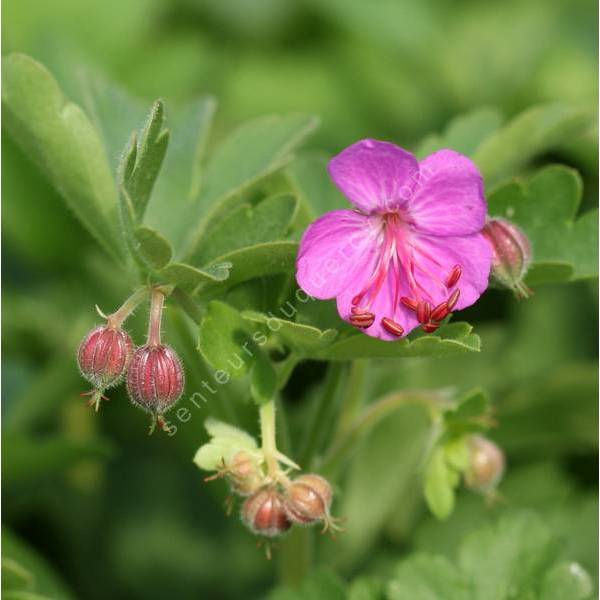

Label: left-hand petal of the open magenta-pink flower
[296,210,380,300]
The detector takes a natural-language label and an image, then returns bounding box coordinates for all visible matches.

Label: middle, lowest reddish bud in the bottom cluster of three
[242,486,292,537]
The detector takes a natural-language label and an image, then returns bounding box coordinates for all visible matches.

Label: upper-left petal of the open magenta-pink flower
[329,139,419,212]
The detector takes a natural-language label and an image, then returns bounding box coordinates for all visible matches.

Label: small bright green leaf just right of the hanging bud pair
[198,300,256,378]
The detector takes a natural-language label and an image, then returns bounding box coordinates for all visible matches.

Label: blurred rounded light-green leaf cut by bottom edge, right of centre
[386,554,472,600]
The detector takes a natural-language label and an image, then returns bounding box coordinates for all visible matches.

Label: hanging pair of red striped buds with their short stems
[77,289,184,432]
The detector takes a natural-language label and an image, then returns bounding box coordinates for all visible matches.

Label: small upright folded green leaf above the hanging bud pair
[119,100,169,223]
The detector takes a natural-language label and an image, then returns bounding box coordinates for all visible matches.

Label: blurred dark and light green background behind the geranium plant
[2,0,598,599]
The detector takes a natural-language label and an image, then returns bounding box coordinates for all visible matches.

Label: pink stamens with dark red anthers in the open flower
[350,212,462,337]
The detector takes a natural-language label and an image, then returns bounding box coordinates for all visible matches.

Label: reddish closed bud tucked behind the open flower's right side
[483,218,531,298]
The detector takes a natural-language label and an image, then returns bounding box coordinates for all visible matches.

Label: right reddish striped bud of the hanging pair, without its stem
[127,344,184,417]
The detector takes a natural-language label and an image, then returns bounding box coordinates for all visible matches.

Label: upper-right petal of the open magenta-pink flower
[406,150,487,236]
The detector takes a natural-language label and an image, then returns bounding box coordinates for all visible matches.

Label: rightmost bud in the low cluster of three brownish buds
[285,473,333,528]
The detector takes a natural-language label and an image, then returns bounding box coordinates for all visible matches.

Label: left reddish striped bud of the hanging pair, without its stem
[77,325,133,391]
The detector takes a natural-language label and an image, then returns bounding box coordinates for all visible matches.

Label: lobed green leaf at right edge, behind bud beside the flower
[489,165,598,285]
